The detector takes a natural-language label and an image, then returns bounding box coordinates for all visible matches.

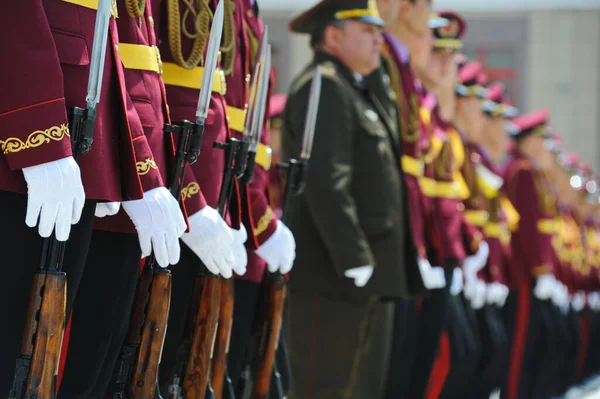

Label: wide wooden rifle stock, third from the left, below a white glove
[183,273,221,399]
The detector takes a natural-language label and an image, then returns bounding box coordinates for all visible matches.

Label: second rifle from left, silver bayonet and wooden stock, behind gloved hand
[113,2,223,399]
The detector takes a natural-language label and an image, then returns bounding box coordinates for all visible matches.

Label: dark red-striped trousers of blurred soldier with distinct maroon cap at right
[502,286,549,399]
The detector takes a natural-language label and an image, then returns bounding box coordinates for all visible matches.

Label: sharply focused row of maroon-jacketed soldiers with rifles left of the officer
[0,0,295,399]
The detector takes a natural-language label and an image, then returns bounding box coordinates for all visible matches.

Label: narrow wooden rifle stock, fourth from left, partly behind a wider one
[211,279,234,399]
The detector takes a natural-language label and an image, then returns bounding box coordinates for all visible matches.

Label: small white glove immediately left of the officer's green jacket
[255,220,296,274]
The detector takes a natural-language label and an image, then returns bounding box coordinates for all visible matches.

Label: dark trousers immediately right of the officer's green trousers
[385,301,419,399]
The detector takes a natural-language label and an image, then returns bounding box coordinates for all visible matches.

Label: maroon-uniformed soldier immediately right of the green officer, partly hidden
[378,0,446,399]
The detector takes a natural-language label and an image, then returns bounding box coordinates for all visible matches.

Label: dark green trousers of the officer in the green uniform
[289,292,392,399]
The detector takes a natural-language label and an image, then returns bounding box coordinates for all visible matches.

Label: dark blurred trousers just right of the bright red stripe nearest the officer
[440,295,481,399]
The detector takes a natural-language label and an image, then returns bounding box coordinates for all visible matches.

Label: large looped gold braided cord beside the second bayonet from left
[167,0,213,69]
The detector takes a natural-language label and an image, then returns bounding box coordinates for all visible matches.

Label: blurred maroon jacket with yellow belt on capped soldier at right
[504,152,556,286]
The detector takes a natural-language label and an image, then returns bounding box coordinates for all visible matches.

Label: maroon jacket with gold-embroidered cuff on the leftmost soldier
[0,0,161,201]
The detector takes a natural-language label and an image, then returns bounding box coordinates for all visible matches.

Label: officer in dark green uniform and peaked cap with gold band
[282,0,423,399]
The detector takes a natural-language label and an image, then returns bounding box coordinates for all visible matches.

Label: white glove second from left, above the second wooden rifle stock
[123,187,186,267]
